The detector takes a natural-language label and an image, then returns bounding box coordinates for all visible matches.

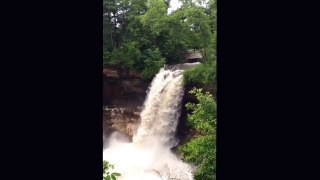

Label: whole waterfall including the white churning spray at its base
[103,63,197,180]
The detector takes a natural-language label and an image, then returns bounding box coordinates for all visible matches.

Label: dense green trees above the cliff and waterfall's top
[103,0,212,76]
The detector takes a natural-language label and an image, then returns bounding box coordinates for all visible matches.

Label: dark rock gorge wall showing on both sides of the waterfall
[103,66,216,147]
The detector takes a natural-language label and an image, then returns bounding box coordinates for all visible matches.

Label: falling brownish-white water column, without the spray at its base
[133,69,184,147]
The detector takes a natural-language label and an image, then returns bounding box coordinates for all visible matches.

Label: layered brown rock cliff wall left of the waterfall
[103,66,151,140]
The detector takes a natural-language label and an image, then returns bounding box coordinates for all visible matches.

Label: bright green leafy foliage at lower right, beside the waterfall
[179,88,216,180]
